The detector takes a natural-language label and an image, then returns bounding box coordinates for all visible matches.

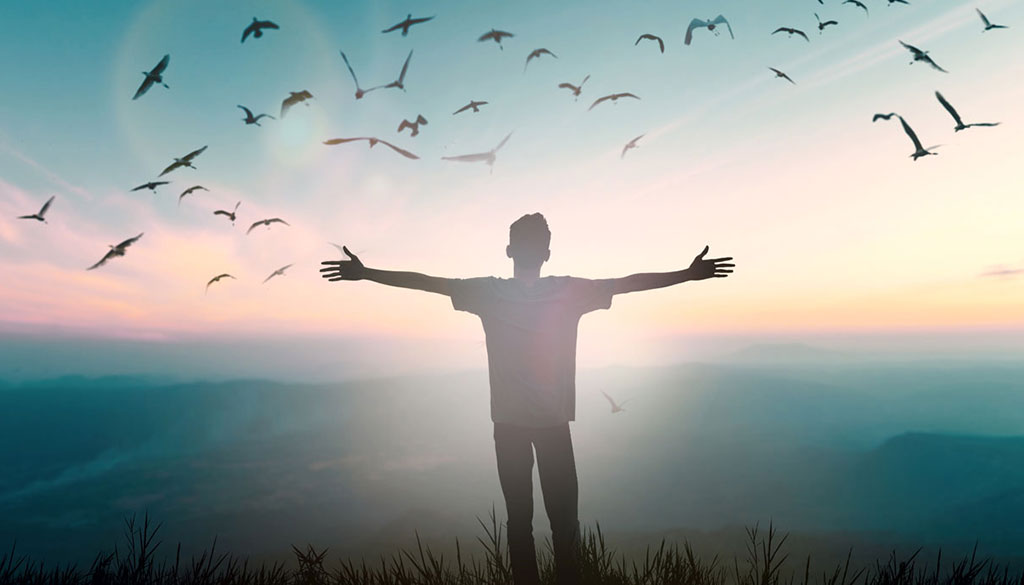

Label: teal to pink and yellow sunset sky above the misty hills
[0,0,1024,377]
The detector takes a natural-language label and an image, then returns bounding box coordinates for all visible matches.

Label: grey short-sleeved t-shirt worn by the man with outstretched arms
[451,277,612,426]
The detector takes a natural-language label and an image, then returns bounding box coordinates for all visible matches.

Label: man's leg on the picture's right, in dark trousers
[534,423,580,585]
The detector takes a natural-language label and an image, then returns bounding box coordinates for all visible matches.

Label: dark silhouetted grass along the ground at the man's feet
[0,509,1024,585]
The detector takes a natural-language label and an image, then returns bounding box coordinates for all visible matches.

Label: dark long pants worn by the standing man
[495,422,580,585]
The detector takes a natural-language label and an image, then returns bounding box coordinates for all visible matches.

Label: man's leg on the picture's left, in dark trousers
[495,422,541,585]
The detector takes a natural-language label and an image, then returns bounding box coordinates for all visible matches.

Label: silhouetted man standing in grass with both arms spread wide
[321,213,734,585]
